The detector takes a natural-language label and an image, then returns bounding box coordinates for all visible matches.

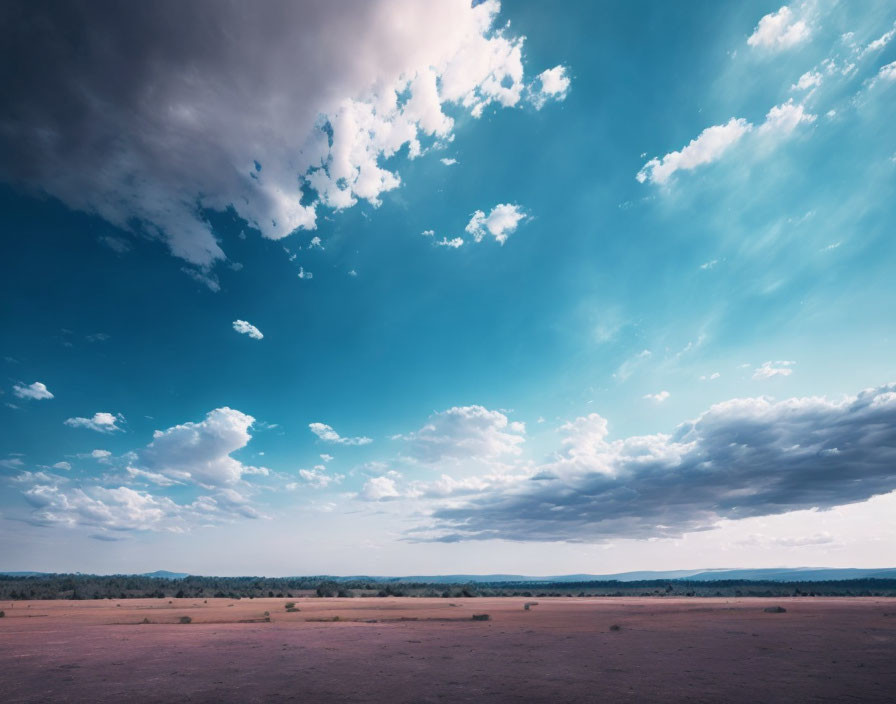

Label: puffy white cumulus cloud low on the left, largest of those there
[134,406,266,486]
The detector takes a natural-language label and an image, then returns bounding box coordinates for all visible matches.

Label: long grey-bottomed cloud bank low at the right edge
[430,384,896,542]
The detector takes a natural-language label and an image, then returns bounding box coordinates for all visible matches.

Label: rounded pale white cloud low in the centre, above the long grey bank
[401,406,526,463]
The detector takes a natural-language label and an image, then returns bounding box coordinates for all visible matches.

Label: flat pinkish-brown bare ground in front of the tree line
[0,598,896,704]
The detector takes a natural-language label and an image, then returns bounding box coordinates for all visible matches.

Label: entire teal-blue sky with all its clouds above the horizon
[0,0,896,576]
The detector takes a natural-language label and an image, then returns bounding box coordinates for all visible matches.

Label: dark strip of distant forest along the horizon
[0,574,896,601]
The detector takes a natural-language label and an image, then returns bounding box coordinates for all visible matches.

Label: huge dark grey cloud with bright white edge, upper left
[0,0,560,280]
